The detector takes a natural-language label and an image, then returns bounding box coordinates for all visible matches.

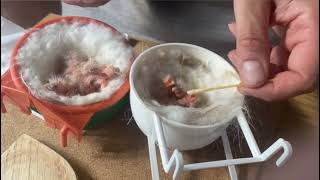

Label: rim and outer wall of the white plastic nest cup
[130,43,235,150]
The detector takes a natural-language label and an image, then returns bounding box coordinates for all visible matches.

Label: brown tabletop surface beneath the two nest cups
[1,11,319,180]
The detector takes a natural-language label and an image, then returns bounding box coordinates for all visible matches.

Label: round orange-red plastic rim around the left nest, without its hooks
[10,16,134,113]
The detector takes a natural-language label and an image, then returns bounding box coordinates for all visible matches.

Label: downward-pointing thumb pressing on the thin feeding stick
[234,0,271,88]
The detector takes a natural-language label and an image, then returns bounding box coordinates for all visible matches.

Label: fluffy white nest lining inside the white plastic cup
[134,46,244,125]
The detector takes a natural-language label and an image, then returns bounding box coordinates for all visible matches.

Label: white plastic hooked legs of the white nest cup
[148,111,292,180]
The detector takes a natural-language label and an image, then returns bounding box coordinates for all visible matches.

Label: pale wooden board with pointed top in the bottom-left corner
[1,134,77,180]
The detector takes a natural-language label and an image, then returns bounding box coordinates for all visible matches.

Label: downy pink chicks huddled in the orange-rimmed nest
[44,53,120,97]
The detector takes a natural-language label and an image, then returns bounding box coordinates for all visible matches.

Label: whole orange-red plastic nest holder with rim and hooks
[1,16,133,147]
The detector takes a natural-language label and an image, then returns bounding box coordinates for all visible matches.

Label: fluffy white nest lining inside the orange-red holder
[16,21,133,105]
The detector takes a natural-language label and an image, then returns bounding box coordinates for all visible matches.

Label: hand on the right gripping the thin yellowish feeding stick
[228,0,319,101]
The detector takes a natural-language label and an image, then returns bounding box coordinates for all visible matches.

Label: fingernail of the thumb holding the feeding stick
[240,60,266,87]
